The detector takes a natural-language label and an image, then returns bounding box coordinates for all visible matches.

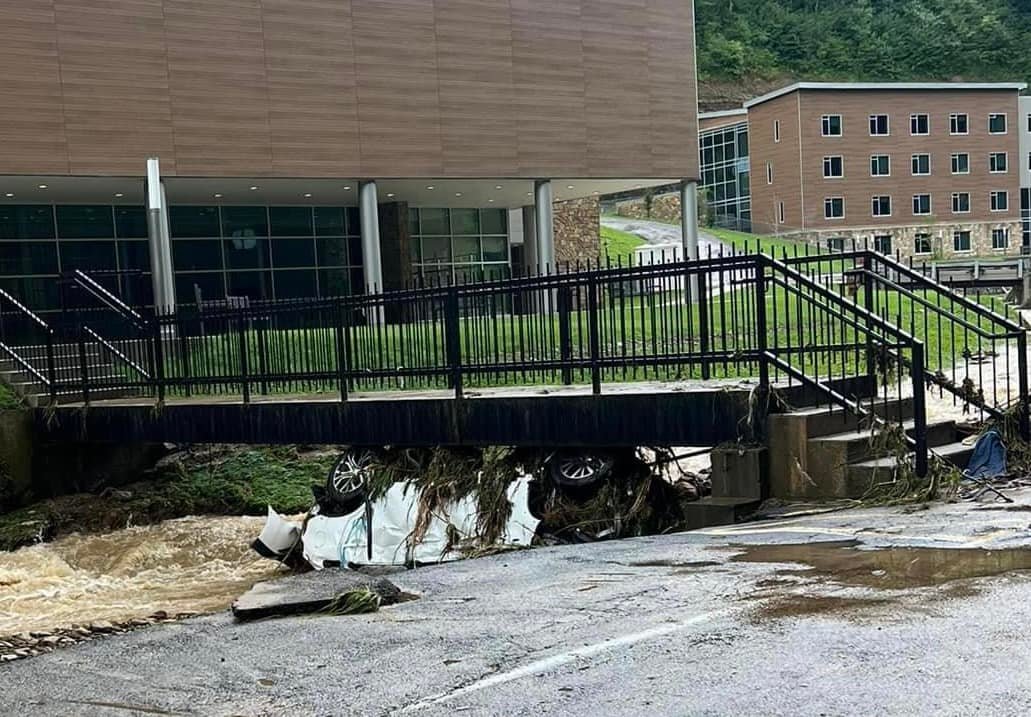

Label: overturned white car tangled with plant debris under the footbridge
[254,447,707,569]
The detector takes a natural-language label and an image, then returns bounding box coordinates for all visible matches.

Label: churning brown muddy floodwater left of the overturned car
[0,517,285,635]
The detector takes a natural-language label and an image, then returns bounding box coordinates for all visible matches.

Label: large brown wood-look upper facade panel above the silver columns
[0,0,697,178]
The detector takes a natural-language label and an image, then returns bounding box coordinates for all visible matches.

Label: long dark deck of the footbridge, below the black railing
[37,380,866,447]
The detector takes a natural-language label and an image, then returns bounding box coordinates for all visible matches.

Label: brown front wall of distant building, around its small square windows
[796,90,1020,230]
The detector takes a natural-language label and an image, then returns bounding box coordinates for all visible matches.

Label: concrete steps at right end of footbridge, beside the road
[767,398,973,499]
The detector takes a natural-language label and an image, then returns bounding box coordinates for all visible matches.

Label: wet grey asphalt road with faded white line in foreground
[6,495,1031,715]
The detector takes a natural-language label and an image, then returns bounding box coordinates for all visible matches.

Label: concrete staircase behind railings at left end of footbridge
[0,344,136,405]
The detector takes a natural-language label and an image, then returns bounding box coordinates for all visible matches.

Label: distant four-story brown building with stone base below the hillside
[699,83,1031,257]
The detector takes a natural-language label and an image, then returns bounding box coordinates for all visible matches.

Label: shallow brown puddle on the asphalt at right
[730,541,1031,590]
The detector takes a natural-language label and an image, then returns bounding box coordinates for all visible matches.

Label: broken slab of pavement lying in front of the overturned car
[233,571,402,620]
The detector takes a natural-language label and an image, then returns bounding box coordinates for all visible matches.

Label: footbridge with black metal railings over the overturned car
[0,250,1029,474]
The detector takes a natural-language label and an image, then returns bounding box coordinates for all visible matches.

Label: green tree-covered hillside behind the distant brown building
[696,0,1031,109]
